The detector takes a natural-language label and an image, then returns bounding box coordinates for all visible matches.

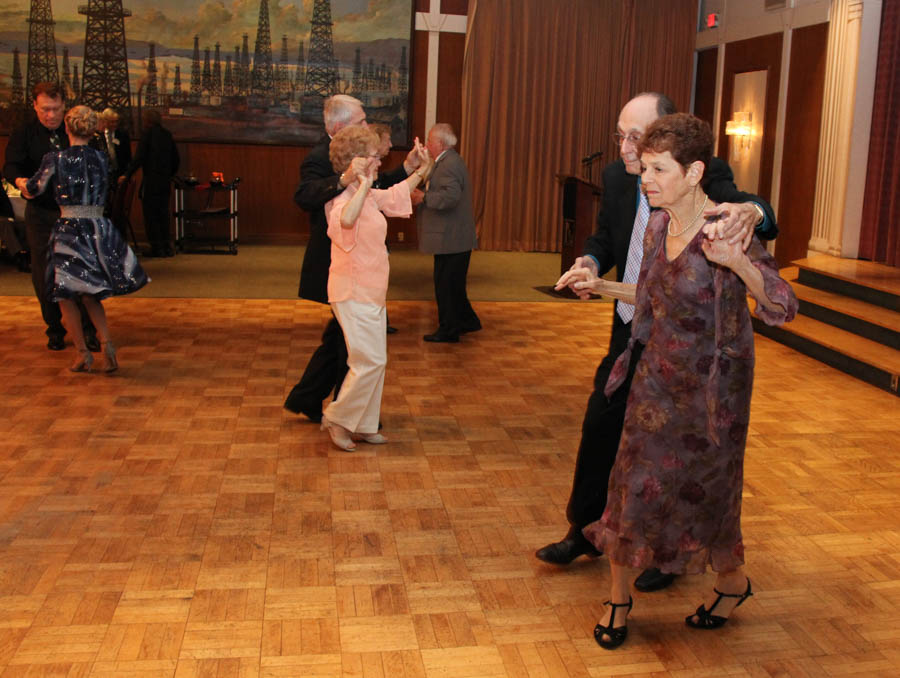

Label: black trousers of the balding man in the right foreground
[566,316,643,530]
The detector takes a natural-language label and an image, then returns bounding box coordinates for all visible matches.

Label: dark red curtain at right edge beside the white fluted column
[859,0,900,266]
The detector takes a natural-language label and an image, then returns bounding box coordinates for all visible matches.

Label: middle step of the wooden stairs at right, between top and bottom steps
[791,282,900,351]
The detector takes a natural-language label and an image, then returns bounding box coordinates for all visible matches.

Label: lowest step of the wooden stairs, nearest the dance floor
[753,315,900,395]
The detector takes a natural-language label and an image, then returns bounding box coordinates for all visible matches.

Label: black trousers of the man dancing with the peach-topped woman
[284,315,349,412]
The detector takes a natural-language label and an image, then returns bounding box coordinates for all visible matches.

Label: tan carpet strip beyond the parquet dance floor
[0,245,612,301]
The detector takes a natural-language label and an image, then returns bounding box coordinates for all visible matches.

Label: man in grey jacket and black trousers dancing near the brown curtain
[416,123,481,343]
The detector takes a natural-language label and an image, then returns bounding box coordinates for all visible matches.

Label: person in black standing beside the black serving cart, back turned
[119,108,181,257]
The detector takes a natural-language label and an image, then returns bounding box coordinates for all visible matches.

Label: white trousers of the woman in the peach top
[323,300,387,434]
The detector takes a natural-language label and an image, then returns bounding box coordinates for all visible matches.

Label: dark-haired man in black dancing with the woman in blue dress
[3,82,100,351]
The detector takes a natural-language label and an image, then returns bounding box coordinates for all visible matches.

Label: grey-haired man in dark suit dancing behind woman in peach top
[284,94,419,421]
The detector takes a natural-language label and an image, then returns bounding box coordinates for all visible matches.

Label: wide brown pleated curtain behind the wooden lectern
[460,0,697,252]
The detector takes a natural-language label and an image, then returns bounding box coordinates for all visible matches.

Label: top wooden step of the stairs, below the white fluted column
[793,255,900,311]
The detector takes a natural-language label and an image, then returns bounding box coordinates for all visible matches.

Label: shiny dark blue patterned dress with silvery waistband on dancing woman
[27,146,150,301]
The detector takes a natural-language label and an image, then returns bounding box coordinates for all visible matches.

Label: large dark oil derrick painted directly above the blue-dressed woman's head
[78,0,131,129]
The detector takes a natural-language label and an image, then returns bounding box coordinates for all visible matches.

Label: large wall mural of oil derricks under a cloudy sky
[0,0,414,146]
